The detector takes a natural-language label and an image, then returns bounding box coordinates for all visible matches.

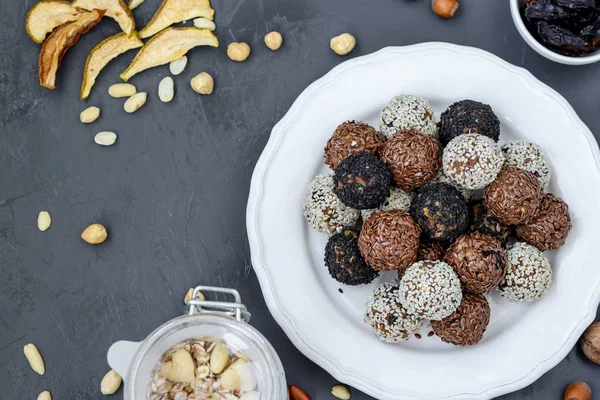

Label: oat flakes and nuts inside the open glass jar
[148,338,260,400]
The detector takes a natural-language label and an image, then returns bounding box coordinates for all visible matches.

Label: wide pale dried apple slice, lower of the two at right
[121,27,219,82]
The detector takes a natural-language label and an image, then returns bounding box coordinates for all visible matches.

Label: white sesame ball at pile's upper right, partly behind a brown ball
[502,140,552,189]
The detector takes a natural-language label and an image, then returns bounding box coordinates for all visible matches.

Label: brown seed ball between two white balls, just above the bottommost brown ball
[444,232,506,293]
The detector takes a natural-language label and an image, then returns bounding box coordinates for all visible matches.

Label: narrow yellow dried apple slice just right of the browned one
[80,32,144,100]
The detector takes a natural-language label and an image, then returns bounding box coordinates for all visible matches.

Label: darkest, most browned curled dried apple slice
[38,10,104,89]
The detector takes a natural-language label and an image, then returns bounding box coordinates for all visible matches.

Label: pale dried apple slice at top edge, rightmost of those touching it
[140,0,215,39]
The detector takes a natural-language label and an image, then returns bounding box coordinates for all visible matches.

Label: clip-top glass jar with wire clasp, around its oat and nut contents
[107,286,288,400]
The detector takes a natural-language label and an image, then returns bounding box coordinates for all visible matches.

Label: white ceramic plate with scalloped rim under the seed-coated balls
[247,43,600,400]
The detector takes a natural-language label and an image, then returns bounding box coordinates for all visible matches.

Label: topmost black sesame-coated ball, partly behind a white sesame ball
[438,100,500,146]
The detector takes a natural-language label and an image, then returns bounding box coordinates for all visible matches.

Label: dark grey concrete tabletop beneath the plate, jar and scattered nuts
[0,0,600,400]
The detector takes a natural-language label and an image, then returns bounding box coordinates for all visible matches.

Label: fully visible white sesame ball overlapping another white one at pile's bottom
[400,261,462,321]
